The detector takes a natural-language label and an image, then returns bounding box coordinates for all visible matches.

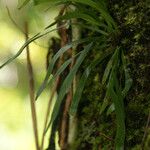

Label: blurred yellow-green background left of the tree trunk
[0,0,58,150]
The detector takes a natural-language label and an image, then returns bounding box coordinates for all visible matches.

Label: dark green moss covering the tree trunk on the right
[74,0,150,150]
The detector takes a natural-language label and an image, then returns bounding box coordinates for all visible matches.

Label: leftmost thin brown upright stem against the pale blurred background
[25,22,40,150]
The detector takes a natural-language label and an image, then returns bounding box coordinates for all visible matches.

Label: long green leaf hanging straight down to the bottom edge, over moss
[103,48,125,150]
